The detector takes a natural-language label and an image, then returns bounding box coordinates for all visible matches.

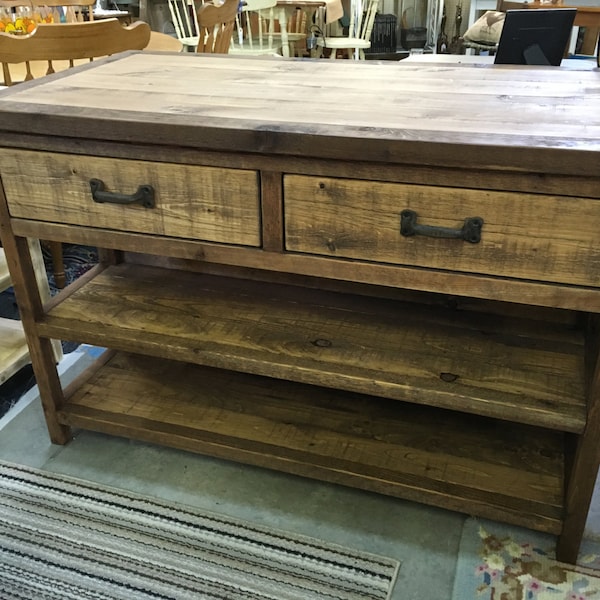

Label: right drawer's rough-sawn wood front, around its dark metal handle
[284,175,600,286]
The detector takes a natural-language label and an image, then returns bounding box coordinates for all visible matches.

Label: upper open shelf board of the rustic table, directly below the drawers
[36,264,586,433]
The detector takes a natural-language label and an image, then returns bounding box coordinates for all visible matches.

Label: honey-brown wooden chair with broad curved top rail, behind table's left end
[0,19,150,287]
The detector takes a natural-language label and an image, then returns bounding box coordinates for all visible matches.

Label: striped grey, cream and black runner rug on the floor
[0,461,399,600]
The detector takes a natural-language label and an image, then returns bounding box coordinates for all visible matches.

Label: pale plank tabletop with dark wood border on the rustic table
[0,52,600,176]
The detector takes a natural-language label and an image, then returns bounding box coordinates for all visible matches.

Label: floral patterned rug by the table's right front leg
[453,518,600,600]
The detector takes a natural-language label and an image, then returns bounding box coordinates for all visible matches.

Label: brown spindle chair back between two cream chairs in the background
[197,0,239,54]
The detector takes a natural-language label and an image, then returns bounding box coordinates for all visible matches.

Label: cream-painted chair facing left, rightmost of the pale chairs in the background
[317,0,379,60]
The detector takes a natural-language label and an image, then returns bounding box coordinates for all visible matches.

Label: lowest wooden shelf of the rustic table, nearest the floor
[59,352,565,533]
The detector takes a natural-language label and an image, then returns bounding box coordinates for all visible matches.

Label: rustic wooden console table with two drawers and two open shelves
[0,52,600,561]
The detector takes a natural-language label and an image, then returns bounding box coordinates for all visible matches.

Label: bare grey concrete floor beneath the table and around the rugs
[0,347,600,600]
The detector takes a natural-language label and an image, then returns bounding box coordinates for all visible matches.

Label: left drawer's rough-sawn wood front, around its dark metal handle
[0,150,261,246]
